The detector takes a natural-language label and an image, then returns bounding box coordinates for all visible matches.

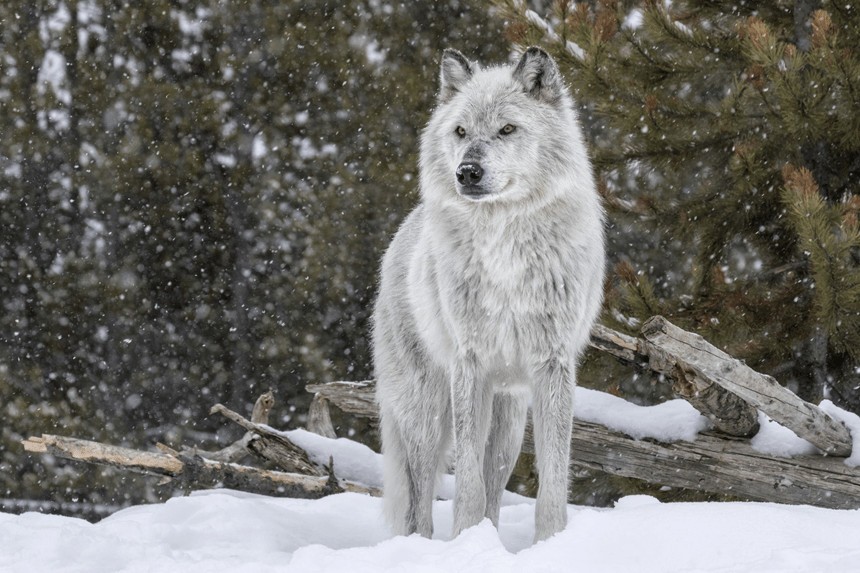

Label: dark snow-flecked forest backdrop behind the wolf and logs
[0,0,860,519]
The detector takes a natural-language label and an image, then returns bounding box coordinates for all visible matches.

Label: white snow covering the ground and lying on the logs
[5,390,860,573]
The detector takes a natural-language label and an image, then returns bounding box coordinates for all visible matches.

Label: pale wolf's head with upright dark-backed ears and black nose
[421,48,590,208]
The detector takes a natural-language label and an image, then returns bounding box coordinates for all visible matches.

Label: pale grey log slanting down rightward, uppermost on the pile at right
[642,316,852,456]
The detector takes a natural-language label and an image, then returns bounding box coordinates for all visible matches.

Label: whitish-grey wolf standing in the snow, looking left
[372,48,605,540]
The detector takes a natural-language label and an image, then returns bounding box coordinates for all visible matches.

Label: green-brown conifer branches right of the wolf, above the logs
[497,0,860,411]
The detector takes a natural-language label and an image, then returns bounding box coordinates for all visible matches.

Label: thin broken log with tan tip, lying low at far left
[23,434,380,499]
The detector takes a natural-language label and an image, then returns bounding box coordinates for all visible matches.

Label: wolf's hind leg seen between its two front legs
[484,393,528,527]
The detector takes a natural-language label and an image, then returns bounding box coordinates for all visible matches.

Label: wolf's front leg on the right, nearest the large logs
[532,358,575,541]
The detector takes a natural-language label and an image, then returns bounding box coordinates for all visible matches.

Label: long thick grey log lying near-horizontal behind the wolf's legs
[313,382,860,509]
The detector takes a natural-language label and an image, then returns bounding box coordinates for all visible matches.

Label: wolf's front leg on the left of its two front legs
[451,356,492,536]
